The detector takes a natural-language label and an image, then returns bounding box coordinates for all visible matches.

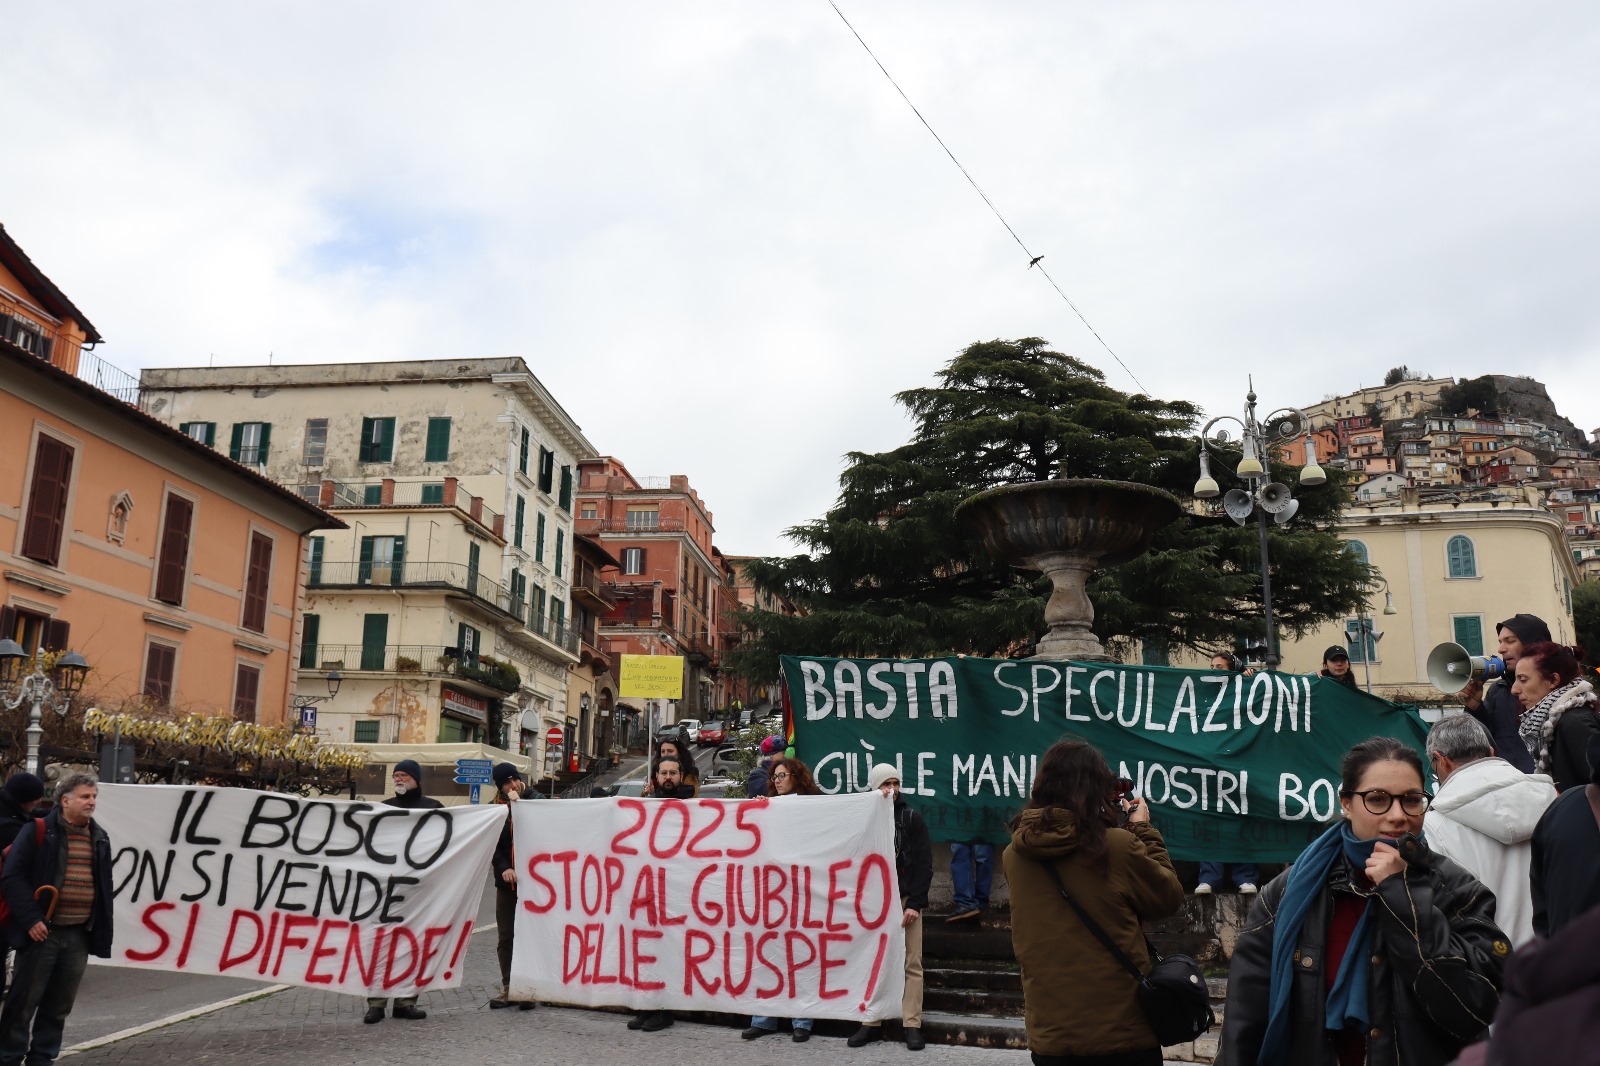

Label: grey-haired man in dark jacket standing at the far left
[0,773,112,1066]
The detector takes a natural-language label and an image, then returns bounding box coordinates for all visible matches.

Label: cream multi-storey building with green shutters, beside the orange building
[141,359,595,767]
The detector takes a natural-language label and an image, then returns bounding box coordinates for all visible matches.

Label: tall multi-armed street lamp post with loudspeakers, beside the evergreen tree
[1195,379,1328,671]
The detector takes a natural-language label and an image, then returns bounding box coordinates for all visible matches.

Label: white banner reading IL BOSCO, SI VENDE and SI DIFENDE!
[94,784,506,997]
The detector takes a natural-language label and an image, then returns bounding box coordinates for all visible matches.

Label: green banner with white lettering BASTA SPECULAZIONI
[782,646,1427,863]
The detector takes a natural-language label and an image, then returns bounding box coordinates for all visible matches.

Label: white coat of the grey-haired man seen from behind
[1422,759,1555,946]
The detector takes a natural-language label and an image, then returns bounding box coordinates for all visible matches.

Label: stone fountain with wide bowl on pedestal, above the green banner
[955,479,1182,661]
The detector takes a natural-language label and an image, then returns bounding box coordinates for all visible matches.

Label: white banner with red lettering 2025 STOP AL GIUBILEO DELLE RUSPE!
[510,792,906,1021]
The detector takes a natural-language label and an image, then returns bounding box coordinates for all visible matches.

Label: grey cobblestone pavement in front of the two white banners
[64,932,1029,1066]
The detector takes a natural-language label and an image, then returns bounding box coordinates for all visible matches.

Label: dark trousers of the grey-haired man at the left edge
[0,925,90,1066]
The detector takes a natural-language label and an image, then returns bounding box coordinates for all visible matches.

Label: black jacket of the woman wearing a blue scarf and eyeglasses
[1216,847,1504,1066]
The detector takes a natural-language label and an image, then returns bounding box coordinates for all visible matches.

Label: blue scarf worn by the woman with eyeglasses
[1256,820,1394,1066]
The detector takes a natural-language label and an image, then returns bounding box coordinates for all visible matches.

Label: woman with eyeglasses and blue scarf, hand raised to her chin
[1218,736,1510,1066]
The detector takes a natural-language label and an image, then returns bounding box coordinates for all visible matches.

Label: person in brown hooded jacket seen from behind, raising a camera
[1003,736,1190,1066]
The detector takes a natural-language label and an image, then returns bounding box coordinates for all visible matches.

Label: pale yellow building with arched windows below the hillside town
[1283,487,1579,699]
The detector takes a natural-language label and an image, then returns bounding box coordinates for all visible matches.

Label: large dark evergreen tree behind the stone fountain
[733,338,1368,677]
